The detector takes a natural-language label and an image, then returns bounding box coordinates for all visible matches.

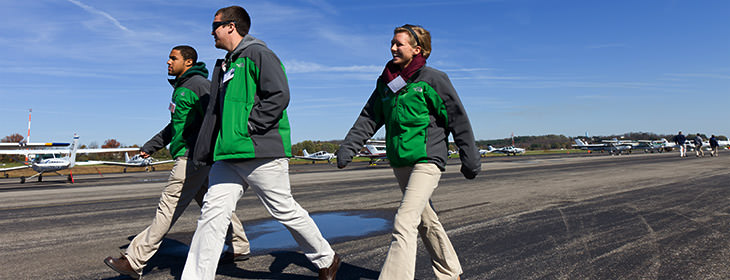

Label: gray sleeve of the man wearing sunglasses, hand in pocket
[248,46,289,134]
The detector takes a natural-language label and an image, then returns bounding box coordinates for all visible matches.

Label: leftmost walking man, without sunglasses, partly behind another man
[104,46,251,279]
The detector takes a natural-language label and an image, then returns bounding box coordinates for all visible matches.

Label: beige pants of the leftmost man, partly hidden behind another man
[126,157,251,274]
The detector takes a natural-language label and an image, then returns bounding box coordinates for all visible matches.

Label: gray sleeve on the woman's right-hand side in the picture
[432,72,481,179]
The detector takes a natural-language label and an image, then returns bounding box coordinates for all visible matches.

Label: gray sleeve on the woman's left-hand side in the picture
[337,91,383,168]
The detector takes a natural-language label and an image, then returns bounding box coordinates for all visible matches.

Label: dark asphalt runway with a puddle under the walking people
[0,151,730,279]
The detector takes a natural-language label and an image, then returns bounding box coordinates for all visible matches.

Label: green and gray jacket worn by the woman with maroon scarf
[337,66,481,174]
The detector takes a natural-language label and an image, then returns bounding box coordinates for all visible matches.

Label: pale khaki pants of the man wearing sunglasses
[180,158,335,280]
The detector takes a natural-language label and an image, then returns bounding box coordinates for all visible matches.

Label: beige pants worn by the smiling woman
[378,163,462,280]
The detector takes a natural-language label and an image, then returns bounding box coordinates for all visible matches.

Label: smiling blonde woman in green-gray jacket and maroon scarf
[337,24,481,280]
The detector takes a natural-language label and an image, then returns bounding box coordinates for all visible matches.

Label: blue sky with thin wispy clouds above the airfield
[0,0,730,145]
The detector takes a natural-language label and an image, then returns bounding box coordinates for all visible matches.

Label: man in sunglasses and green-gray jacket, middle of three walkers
[182,6,340,280]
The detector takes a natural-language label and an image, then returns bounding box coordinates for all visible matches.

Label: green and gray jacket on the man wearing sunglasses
[194,35,291,163]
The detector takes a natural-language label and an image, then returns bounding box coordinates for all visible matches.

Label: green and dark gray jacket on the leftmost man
[141,62,210,158]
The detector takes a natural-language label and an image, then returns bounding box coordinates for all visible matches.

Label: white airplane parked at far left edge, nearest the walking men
[0,135,139,184]
